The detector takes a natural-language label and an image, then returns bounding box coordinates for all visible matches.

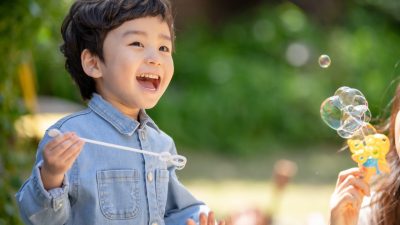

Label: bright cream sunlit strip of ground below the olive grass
[185,180,334,225]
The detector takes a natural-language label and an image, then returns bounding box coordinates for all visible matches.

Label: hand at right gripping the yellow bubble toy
[330,168,370,225]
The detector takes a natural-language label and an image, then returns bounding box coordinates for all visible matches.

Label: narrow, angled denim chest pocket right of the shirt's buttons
[156,169,169,216]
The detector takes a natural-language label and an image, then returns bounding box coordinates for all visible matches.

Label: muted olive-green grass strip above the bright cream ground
[178,146,356,184]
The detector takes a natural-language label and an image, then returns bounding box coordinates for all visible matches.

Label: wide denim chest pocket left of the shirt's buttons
[97,170,140,220]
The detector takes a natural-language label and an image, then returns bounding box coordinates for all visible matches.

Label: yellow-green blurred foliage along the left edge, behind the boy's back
[0,0,65,225]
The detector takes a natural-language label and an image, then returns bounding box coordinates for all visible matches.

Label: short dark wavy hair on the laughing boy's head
[60,0,175,100]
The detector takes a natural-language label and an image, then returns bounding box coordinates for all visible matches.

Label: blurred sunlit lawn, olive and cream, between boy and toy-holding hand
[178,147,356,225]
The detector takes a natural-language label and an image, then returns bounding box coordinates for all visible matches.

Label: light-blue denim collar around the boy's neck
[88,93,160,136]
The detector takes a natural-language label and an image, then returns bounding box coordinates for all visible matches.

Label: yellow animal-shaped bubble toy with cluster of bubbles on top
[320,87,390,182]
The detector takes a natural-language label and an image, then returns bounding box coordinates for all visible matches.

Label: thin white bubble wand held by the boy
[48,129,187,170]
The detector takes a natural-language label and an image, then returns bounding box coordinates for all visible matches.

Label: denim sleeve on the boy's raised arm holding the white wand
[15,132,71,225]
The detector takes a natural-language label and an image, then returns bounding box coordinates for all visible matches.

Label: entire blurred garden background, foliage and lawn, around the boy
[0,0,400,225]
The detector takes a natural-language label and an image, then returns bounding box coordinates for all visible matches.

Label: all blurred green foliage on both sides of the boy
[0,0,400,221]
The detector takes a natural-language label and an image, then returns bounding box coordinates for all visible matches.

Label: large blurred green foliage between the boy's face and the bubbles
[151,3,400,154]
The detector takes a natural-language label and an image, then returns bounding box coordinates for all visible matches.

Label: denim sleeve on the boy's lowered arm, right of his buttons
[164,144,210,225]
